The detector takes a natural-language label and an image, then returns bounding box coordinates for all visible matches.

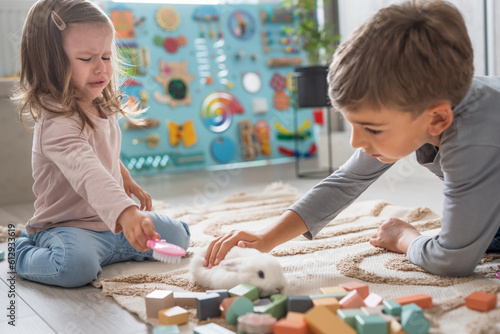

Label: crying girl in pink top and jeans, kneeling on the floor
[13,0,190,287]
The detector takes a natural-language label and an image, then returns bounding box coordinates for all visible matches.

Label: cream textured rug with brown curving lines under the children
[94,183,500,334]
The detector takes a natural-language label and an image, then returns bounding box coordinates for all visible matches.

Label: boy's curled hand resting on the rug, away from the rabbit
[370,218,420,254]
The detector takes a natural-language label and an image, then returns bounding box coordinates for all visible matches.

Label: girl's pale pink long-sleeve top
[26,100,137,235]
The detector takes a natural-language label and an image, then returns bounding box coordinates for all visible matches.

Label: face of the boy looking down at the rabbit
[342,109,439,163]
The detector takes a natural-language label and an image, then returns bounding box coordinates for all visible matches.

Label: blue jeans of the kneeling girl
[15,212,190,288]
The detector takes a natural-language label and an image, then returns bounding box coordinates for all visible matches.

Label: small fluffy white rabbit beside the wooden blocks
[191,246,287,297]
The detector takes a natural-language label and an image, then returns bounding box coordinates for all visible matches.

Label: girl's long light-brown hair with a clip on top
[12,0,137,131]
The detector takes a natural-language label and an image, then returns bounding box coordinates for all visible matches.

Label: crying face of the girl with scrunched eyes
[62,22,113,104]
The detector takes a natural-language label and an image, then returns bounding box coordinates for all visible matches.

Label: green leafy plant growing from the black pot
[281,0,340,66]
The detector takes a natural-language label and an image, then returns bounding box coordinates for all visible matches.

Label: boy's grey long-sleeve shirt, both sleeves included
[290,77,500,276]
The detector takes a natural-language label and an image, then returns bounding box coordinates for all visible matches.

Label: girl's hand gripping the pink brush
[117,206,161,252]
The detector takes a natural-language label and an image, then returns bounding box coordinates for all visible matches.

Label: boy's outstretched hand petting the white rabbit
[204,231,272,268]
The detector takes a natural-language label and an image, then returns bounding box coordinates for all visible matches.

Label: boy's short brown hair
[328,0,474,117]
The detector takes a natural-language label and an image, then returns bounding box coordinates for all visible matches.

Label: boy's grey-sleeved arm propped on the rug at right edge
[407,145,500,276]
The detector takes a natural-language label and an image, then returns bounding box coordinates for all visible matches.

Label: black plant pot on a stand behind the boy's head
[294,66,331,108]
